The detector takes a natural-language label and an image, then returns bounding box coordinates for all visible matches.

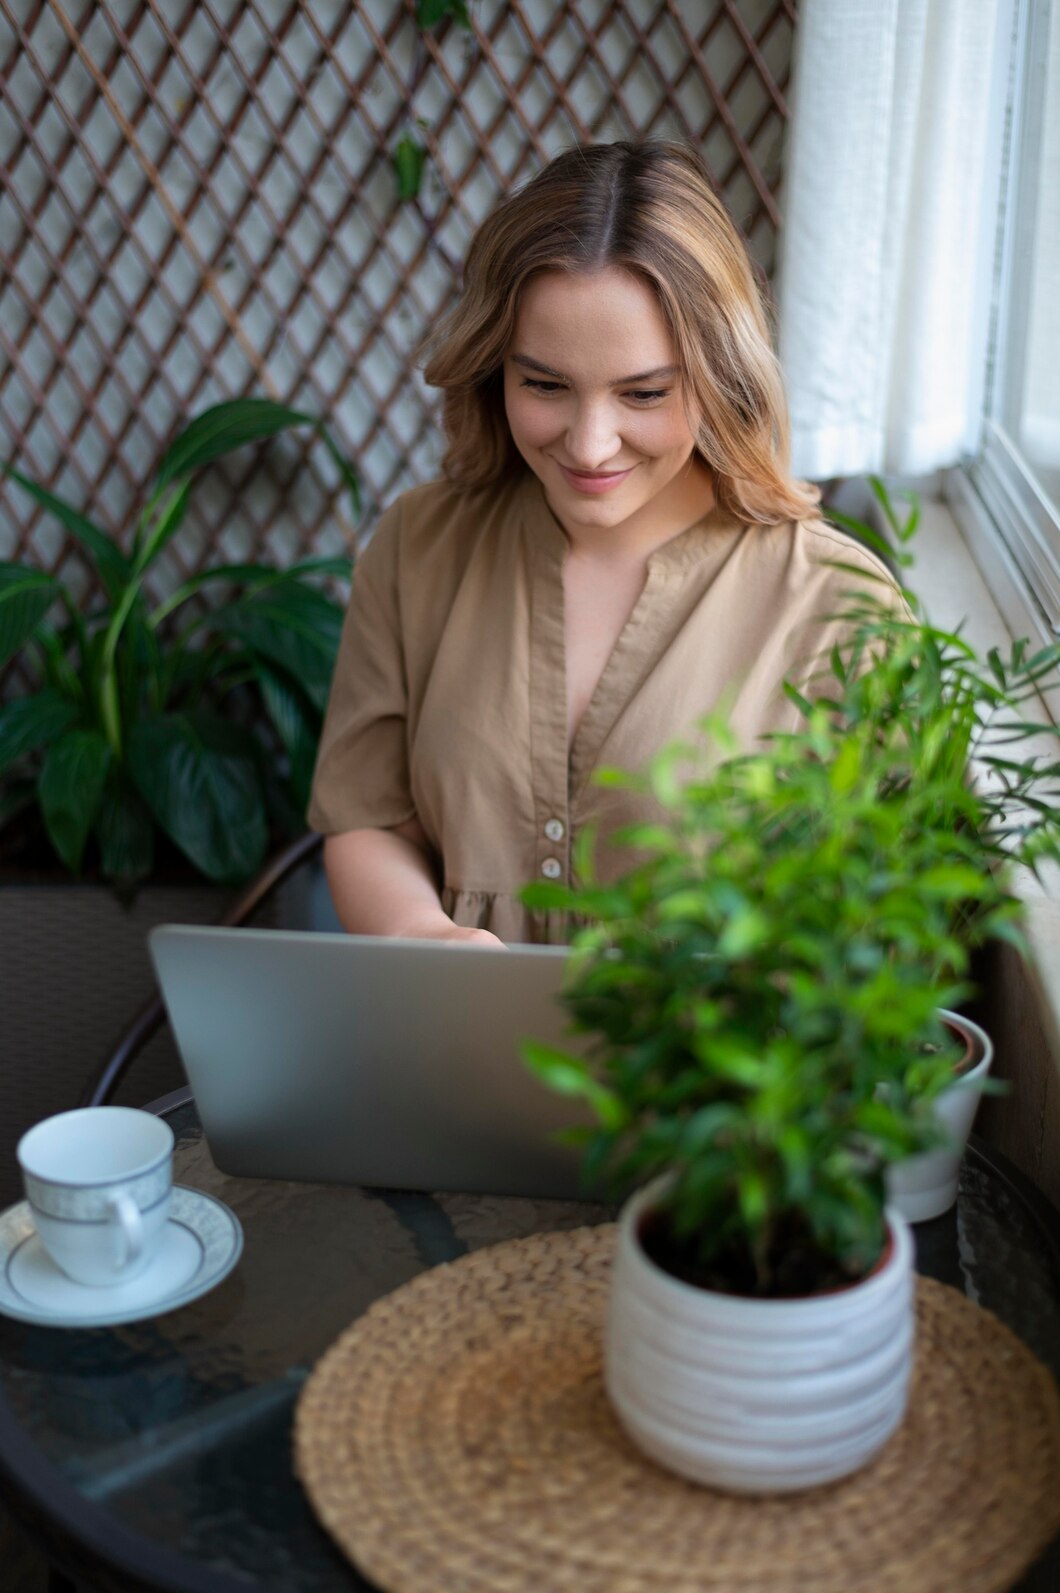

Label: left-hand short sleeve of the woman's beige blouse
[308,503,414,835]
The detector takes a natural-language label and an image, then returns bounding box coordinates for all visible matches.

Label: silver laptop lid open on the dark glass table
[150,924,602,1198]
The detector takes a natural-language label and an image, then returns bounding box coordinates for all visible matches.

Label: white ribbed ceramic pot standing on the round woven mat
[604,1180,913,1493]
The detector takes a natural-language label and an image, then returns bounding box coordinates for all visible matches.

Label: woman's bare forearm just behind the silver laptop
[324,819,504,948]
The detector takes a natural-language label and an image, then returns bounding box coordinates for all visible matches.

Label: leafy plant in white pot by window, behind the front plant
[803,478,1060,1222]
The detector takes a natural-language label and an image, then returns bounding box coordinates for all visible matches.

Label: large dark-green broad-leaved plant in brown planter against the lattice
[0,398,357,1200]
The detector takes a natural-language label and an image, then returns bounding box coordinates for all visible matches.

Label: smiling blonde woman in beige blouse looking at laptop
[309,143,883,945]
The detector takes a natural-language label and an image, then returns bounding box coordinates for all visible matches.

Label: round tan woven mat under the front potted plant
[295,1225,1060,1593]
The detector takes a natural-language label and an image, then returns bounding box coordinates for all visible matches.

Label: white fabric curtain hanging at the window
[778,0,1012,479]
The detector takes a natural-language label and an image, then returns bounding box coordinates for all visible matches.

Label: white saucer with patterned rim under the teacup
[0,1184,242,1327]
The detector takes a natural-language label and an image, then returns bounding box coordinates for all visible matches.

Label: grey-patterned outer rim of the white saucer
[0,1184,244,1329]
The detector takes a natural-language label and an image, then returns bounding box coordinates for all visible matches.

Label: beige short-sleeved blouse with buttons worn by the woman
[309,472,889,941]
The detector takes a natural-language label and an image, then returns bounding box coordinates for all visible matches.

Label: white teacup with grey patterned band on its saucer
[18,1106,174,1287]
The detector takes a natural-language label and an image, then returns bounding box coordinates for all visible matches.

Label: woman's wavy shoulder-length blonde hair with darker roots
[424,142,821,524]
